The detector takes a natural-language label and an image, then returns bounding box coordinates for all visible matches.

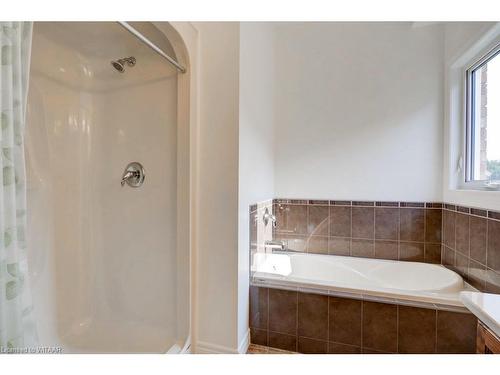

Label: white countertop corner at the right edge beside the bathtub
[460,292,500,337]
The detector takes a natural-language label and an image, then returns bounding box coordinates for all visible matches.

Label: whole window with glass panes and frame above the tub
[465,45,500,188]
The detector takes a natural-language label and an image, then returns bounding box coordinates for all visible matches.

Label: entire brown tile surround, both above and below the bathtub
[250,199,500,354]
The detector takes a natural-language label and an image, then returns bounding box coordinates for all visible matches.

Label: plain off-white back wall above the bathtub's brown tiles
[275,22,443,201]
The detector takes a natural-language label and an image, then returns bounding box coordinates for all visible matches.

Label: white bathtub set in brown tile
[252,253,473,308]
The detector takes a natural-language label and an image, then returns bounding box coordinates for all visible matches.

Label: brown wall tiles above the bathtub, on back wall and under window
[251,199,500,293]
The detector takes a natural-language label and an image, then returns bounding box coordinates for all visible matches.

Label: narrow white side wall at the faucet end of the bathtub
[238,22,275,352]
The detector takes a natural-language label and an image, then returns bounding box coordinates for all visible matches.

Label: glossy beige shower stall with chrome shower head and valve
[25,22,190,353]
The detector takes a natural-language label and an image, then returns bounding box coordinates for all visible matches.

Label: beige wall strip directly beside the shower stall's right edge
[190,22,240,352]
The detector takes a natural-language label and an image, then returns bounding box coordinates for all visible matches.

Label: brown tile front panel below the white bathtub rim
[250,286,477,354]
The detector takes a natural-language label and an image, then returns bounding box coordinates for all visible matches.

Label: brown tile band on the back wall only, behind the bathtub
[273,199,442,263]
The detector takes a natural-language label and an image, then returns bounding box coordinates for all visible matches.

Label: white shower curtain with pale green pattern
[0,22,37,354]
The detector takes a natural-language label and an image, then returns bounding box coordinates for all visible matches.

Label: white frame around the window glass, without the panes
[460,41,500,190]
